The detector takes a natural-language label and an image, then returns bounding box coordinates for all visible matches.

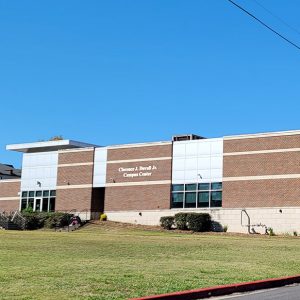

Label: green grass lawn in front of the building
[0,223,300,300]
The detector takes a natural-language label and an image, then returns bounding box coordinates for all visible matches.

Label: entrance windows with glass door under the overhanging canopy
[20,190,56,212]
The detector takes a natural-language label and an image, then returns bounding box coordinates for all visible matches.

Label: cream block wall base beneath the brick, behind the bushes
[105,207,300,234]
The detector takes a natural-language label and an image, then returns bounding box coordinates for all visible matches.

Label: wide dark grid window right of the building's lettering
[171,182,222,208]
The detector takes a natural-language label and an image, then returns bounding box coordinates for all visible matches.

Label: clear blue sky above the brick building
[0,0,300,166]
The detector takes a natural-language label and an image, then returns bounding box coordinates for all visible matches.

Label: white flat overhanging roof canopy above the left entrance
[6,140,100,153]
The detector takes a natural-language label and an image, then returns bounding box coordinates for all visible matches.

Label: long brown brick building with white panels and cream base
[0,131,300,232]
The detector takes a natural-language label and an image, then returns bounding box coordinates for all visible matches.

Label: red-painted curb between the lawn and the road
[130,275,300,300]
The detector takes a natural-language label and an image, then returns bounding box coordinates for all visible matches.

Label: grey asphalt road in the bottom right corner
[208,284,300,300]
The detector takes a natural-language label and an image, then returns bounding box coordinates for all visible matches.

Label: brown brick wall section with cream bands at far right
[223,135,300,208]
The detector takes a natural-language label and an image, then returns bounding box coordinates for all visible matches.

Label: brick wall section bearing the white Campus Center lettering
[104,143,172,211]
